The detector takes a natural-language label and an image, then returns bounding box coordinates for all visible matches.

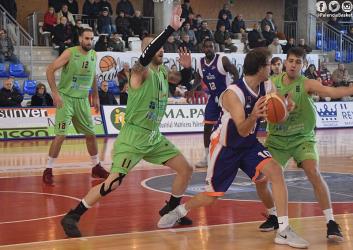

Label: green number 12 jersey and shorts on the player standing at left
[55,47,97,135]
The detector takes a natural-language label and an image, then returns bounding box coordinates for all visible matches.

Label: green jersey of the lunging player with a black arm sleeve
[125,65,168,132]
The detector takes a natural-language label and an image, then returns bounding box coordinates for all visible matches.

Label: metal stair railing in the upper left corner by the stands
[0,5,33,79]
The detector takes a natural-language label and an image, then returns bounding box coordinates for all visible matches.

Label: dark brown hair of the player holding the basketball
[243,47,272,76]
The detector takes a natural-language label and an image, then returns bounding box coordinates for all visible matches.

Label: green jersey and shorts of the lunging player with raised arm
[111,65,180,174]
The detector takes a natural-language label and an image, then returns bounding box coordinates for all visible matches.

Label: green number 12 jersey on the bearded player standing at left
[58,47,97,98]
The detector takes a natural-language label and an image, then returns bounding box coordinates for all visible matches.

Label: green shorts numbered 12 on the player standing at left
[55,93,95,135]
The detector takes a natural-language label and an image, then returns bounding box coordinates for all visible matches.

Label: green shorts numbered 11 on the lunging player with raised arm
[110,124,180,174]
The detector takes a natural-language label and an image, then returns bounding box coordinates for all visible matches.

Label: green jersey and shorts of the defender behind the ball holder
[266,73,319,167]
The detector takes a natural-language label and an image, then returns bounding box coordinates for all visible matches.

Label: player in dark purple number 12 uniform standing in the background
[194,38,239,168]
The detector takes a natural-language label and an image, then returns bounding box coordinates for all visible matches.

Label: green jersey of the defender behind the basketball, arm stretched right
[268,73,316,137]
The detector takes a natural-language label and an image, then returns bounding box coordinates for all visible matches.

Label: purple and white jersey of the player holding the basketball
[212,78,272,149]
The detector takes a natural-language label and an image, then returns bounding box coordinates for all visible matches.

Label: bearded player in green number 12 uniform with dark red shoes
[43,29,109,185]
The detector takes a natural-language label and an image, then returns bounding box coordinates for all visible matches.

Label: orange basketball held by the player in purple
[266,93,288,123]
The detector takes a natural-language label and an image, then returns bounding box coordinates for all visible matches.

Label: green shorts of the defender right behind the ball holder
[265,136,319,168]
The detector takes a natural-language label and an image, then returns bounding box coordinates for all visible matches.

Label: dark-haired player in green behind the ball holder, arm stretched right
[256,48,353,241]
